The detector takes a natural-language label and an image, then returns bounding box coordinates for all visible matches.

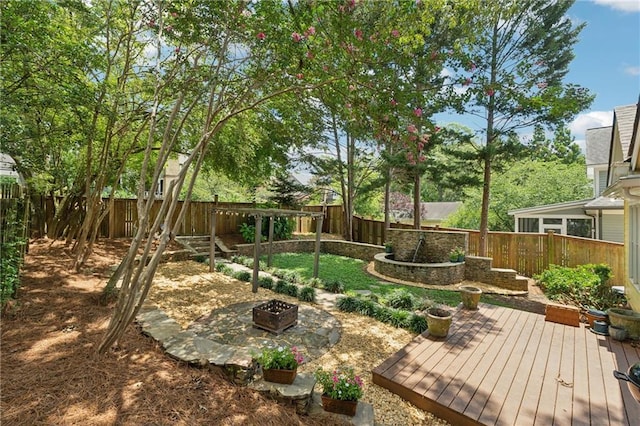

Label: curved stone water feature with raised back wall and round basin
[374,229,469,285]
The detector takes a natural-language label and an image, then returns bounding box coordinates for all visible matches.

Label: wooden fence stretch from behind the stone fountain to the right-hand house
[354,217,625,285]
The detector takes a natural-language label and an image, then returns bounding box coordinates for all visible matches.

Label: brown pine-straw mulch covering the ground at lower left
[0,240,326,425]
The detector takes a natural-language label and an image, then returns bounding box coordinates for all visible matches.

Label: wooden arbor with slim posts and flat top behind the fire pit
[209,207,324,293]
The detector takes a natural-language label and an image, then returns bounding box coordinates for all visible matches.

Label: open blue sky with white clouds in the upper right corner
[566,0,640,147]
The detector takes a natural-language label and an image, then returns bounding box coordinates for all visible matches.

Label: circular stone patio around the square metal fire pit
[187,300,342,360]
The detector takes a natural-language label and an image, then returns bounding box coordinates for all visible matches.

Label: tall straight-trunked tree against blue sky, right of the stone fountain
[461,0,593,255]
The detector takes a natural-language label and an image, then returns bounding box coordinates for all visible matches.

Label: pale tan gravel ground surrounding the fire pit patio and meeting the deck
[148,262,448,425]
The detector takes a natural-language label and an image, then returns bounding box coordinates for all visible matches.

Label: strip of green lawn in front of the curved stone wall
[261,253,460,306]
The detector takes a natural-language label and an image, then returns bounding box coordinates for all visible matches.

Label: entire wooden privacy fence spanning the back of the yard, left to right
[31,199,625,285]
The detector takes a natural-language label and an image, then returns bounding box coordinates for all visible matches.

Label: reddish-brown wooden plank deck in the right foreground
[373,304,640,426]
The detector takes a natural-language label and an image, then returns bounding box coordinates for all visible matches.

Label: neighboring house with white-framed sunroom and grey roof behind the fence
[509,126,624,242]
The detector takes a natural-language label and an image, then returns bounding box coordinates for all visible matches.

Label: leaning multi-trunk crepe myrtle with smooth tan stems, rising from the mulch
[98,0,360,352]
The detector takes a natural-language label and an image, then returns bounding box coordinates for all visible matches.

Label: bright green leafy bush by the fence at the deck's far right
[534,264,625,310]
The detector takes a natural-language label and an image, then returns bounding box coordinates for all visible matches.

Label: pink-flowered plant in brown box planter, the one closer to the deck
[314,367,363,417]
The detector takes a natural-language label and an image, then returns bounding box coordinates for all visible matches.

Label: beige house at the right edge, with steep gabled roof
[603,97,640,312]
